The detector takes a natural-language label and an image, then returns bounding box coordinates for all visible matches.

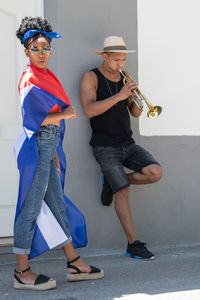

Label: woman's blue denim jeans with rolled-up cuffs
[13,124,72,254]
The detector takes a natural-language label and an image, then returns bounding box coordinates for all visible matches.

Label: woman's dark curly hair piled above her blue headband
[16,17,52,48]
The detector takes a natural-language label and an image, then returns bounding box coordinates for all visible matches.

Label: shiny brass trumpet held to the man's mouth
[119,70,162,119]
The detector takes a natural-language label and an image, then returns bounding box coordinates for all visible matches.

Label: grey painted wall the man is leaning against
[45,0,200,249]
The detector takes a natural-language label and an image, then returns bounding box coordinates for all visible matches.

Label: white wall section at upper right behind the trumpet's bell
[137,0,200,136]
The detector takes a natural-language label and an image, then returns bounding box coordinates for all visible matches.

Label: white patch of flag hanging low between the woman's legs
[37,200,68,249]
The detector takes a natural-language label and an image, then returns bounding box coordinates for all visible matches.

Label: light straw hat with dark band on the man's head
[95,36,136,54]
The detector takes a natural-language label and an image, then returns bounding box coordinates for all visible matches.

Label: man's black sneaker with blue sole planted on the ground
[126,240,155,260]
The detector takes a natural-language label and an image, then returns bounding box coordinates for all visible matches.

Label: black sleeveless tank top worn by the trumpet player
[90,68,134,147]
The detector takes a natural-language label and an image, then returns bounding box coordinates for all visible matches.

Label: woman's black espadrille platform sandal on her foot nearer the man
[67,256,104,281]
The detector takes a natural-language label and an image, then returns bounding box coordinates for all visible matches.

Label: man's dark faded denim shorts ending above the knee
[93,143,159,193]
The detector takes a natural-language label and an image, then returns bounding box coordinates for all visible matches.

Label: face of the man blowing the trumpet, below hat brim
[103,52,126,73]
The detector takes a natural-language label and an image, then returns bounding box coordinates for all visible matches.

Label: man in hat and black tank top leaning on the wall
[80,36,162,259]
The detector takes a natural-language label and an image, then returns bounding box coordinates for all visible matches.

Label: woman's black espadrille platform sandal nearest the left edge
[14,267,56,291]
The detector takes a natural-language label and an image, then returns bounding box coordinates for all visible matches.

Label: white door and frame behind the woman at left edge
[0,0,44,237]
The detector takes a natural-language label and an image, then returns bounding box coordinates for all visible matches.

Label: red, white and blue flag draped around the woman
[14,64,87,258]
